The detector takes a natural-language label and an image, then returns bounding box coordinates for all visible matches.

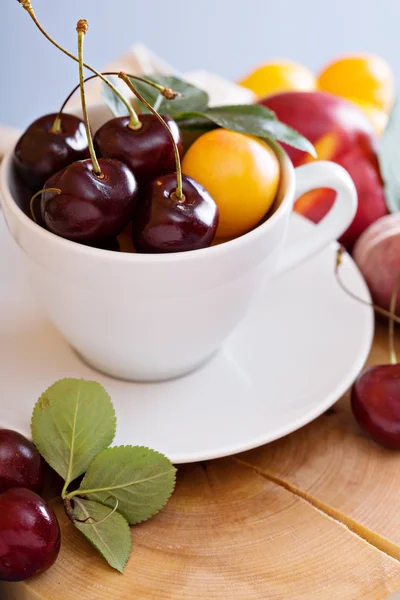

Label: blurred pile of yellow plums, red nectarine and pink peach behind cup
[240,54,400,310]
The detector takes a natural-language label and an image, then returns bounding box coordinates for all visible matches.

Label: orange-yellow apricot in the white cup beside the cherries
[182,129,280,238]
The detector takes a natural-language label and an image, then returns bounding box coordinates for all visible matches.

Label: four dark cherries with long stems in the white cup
[13,7,218,253]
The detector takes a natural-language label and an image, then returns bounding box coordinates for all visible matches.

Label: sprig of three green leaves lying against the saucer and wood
[31,378,176,573]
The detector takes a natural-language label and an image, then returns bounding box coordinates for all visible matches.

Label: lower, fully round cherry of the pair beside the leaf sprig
[0,488,61,581]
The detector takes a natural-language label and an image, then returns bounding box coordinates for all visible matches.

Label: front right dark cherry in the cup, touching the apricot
[132,173,218,253]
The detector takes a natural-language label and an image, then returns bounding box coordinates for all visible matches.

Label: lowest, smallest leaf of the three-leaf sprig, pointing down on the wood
[74,498,132,573]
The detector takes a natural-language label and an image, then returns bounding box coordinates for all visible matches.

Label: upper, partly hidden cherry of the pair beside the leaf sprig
[0,429,43,493]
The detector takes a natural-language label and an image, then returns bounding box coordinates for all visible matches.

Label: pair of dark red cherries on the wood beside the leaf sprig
[0,429,61,581]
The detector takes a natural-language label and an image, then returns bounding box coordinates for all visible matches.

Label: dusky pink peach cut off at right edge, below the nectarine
[353,213,400,314]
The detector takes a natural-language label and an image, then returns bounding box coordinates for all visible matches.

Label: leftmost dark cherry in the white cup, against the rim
[13,113,89,192]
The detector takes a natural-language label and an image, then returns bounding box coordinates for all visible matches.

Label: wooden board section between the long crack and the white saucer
[239,324,400,559]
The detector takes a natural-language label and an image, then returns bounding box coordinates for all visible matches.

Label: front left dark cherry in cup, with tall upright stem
[41,158,138,242]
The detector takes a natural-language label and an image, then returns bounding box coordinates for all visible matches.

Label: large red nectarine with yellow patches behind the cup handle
[260,92,387,250]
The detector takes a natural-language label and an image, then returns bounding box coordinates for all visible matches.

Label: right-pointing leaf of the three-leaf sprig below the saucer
[74,446,176,525]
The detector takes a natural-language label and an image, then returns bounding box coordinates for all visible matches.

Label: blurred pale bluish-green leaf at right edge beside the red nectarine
[378,102,400,213]
